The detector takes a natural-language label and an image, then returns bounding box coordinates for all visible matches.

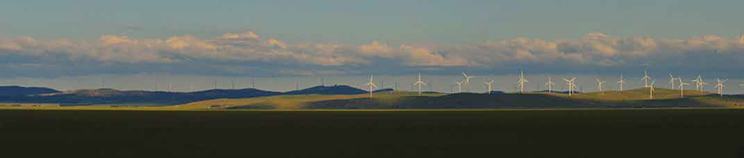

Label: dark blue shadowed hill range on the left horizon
[0,85,367,105]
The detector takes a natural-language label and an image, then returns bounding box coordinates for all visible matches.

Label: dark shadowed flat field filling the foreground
[0,109,744,158]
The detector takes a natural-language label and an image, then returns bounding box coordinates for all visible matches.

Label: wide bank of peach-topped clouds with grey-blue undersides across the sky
[0,32,744,76]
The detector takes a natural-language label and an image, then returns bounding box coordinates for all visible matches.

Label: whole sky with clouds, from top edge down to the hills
[0,0,744,91]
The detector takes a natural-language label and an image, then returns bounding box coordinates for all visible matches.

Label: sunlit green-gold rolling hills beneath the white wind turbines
[179,88,744,109]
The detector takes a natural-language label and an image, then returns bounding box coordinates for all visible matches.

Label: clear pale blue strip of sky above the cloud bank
[5,0,744,43]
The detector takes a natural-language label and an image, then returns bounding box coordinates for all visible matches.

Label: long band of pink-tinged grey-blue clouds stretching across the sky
[0,32,744,76]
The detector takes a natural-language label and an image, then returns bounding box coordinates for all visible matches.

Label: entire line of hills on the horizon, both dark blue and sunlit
[0,85,744,109]
